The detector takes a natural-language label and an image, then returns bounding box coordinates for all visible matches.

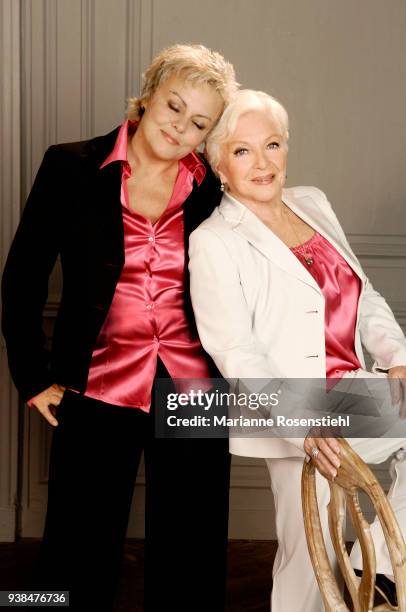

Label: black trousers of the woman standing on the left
[32,366,230,612]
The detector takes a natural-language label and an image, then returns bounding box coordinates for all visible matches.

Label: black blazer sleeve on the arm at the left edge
[1,147,62,401]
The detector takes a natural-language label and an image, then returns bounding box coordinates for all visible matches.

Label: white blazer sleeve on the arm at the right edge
[318,190,406,373]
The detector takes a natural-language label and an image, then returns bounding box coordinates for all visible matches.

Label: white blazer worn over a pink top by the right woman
[189,187,406,457]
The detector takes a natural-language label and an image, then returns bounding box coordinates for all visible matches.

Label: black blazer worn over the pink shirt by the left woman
[2,128,221,401]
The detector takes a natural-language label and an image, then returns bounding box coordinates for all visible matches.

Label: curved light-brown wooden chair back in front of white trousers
[302,439,406,612]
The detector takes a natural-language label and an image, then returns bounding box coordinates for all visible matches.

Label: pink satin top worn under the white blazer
[291,232,361,379]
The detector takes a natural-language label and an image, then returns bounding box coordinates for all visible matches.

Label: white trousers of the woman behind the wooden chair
[265,370,406,612]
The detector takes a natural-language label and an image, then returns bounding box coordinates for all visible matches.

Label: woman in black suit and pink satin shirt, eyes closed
[2,45,237,612]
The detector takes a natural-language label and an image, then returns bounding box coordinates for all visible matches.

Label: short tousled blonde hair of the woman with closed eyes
[127,45,238,119]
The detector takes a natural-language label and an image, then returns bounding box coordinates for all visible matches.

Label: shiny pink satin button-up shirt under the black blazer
[85,121,210,412]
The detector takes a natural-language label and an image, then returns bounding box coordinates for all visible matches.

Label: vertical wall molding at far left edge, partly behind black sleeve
[0,0,21,542]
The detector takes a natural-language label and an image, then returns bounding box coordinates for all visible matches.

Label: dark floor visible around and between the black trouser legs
[0,539,276,612]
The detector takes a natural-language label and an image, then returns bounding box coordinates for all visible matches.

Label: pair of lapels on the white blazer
[219,189,362,294]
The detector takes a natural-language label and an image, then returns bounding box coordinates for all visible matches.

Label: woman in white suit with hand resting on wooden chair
[189,90,406,612]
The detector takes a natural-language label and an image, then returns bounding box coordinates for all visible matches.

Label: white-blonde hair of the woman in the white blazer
[205,89,289,171]
